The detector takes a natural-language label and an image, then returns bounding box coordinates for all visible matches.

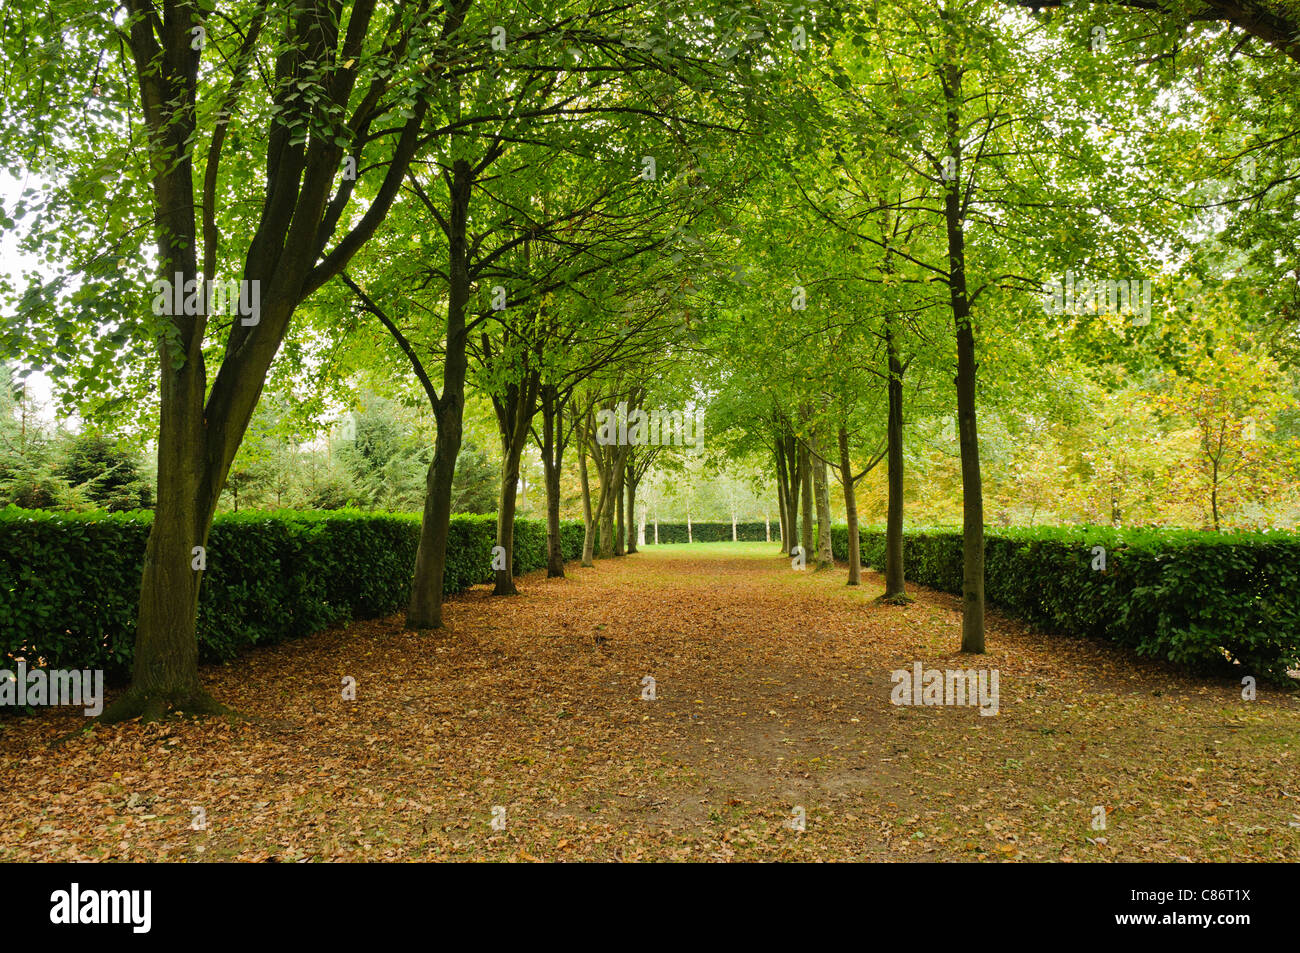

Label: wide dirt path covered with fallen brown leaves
[0,543,1300,861]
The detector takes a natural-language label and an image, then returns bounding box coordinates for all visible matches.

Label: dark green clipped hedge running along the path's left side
[0,507,582,680]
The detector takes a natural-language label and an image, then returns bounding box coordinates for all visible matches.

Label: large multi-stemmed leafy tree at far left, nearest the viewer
[3,0,441,720]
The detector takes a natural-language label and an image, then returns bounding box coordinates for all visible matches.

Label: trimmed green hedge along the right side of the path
[831,527,1300,679]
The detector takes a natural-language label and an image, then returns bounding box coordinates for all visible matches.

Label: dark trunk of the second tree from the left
[406,159,473,629]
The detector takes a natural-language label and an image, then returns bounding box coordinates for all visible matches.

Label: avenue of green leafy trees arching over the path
[0,0,1300,718]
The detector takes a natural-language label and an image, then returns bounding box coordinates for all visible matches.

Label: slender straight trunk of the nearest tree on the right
[944,51,984,653]
